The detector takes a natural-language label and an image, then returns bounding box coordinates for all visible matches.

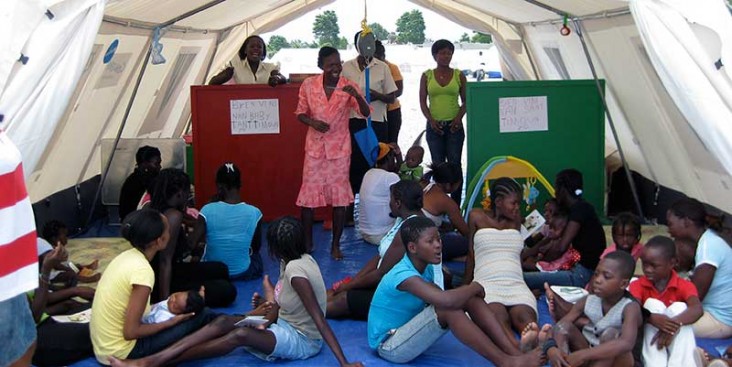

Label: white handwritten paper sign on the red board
[229,99,280,135]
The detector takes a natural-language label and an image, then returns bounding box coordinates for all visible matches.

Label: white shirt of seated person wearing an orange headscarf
[358,168,399,236]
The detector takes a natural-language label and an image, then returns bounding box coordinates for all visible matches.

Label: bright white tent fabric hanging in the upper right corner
[630,0,732,180]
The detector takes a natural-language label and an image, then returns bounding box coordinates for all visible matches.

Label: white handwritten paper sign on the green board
[498,96,549,133]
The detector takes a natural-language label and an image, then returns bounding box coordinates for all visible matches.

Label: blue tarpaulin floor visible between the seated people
[67,220,731,367]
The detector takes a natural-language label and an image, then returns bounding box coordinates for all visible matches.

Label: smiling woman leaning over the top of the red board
[208,35,287,87]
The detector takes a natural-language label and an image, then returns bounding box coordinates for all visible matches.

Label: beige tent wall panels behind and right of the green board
[526,7,732,216]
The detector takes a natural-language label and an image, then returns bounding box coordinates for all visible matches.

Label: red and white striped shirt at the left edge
[0,130,38,301]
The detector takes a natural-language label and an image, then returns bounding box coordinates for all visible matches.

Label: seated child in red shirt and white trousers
[629,236,704,366]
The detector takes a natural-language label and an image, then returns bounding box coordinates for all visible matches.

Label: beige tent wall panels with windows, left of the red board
[29,23,216,200]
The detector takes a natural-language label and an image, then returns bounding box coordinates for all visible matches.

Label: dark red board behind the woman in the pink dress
[191,84,328,221]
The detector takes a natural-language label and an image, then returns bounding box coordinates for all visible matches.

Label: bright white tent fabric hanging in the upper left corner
[0,0,105,187]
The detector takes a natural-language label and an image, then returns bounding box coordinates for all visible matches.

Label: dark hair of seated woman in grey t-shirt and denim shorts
[267,216,307,262]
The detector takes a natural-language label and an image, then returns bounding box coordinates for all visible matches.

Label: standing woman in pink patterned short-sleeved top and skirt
[295,47,370,260]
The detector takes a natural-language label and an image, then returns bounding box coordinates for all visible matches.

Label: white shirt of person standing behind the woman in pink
[341,58,397,122]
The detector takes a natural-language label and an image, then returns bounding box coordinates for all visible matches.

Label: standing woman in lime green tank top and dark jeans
[419,39,467,206]
